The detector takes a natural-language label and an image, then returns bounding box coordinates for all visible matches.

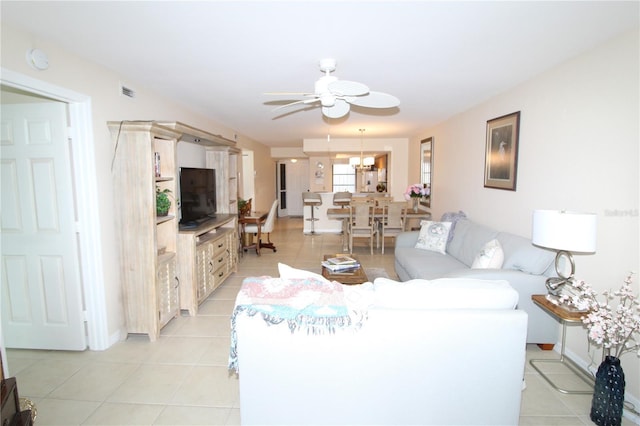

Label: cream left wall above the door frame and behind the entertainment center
[0,23,275,341]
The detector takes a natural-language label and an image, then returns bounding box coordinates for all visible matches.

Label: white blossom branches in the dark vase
[558,272,640,358]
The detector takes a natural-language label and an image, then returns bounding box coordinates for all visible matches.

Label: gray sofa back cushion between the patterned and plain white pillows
[447,219,505,267]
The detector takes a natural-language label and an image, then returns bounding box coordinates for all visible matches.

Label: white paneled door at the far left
[0,102,87,350]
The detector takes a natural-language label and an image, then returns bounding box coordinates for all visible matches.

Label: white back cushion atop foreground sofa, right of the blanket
[373,278,518,309]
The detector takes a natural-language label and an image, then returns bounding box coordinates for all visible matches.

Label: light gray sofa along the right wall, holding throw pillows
[395,218,559,344]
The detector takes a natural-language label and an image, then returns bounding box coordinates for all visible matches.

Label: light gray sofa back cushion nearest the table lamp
[498,232,555,275]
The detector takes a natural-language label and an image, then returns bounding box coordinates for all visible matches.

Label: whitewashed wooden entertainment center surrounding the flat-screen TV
[108,121,241,341]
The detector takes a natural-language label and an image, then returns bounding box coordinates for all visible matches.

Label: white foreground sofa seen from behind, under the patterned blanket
[232,272,527,425]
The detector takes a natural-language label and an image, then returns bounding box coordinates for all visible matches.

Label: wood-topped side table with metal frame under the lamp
[529,294,594,395]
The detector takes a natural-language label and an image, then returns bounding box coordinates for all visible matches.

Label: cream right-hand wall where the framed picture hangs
[411,32,640,402]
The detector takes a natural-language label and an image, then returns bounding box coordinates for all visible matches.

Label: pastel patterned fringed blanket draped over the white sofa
[229,277,366,372]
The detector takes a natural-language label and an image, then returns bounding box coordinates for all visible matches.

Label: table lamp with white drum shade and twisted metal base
[531,210,597,296]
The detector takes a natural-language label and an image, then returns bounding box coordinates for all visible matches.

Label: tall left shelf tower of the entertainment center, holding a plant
[108,121,180,341]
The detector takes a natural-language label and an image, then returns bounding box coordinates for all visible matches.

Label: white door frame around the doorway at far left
[0,68,110,350]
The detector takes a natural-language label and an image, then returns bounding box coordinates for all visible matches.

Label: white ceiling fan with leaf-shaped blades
[266,59,400,118]
